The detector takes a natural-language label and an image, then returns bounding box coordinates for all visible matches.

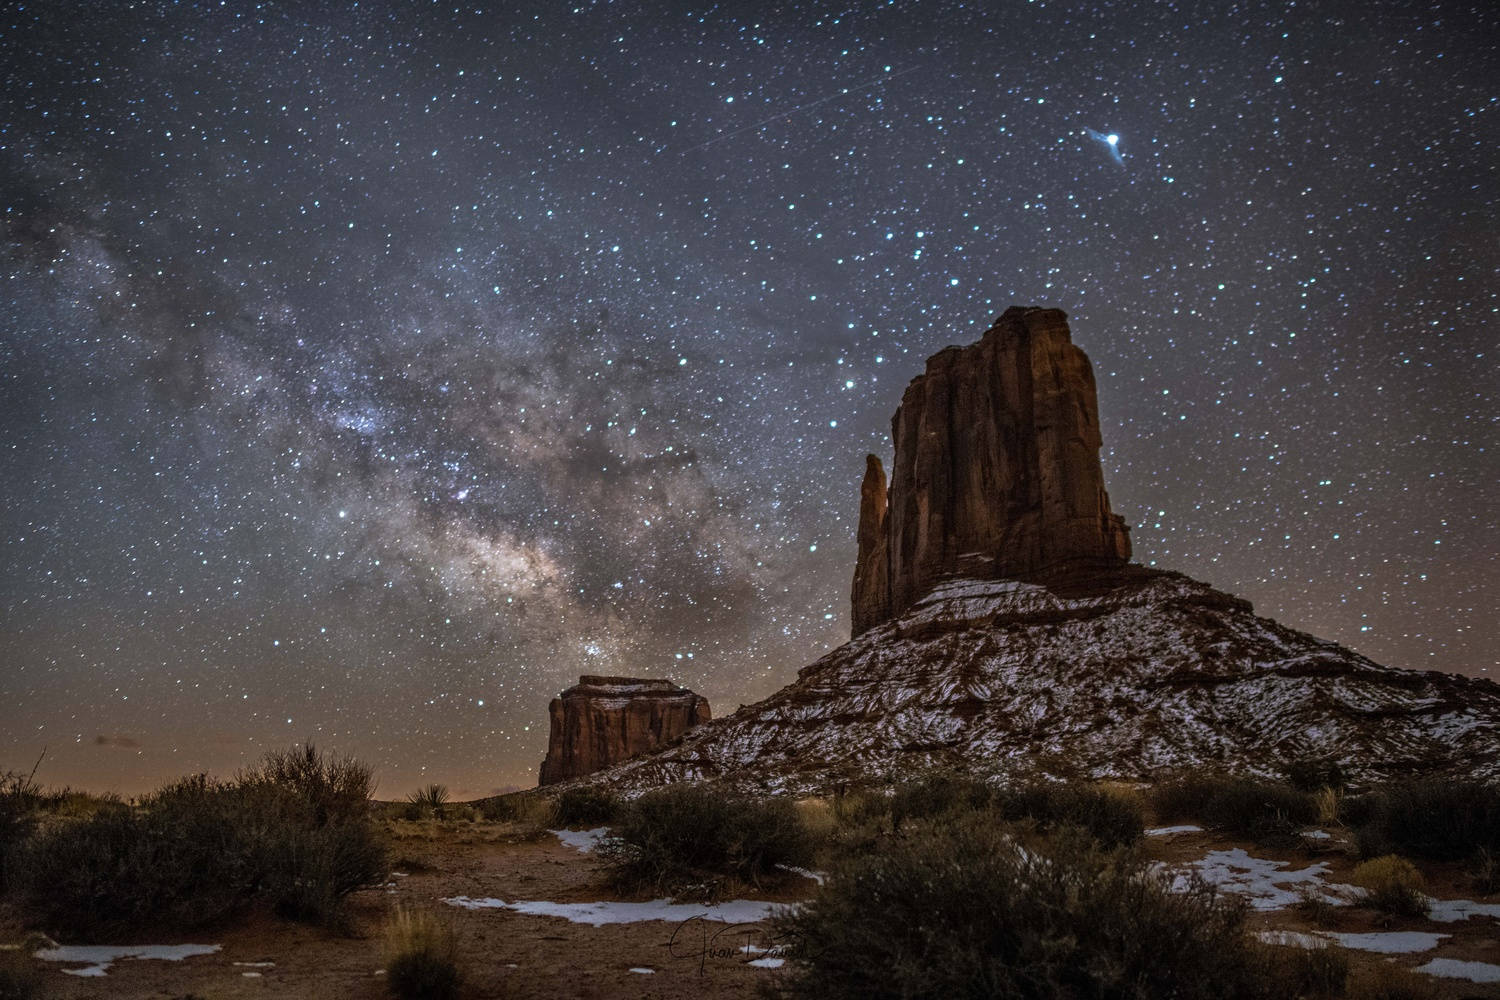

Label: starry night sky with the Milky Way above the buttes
[0,0,1500,795]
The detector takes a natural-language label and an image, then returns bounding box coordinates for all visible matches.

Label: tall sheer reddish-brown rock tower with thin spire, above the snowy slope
[852,307,1130,636]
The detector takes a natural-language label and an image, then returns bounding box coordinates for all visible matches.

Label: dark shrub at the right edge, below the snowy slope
[1344,778,1500,861]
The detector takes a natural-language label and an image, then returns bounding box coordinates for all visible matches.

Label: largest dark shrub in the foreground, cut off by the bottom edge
[773,811,1295,1000]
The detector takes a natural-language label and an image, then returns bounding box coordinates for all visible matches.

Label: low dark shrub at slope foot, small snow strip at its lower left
[1151,774,1319,840]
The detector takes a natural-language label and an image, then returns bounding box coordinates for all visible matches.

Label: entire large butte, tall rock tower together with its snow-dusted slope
[579,307,1500,795]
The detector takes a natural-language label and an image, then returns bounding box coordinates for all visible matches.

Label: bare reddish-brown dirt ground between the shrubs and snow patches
[0,822,1500,1000]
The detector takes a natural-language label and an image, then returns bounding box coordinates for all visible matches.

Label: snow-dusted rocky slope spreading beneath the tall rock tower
[599,567,1500,793]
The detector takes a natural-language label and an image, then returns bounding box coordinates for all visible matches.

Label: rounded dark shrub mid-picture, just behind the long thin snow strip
[606,784,815,891]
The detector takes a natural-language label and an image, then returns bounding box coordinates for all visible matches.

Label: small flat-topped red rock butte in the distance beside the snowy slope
[537,675,710,784]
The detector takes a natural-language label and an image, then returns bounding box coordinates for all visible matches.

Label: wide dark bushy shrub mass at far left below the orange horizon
[17,748,387,939]
